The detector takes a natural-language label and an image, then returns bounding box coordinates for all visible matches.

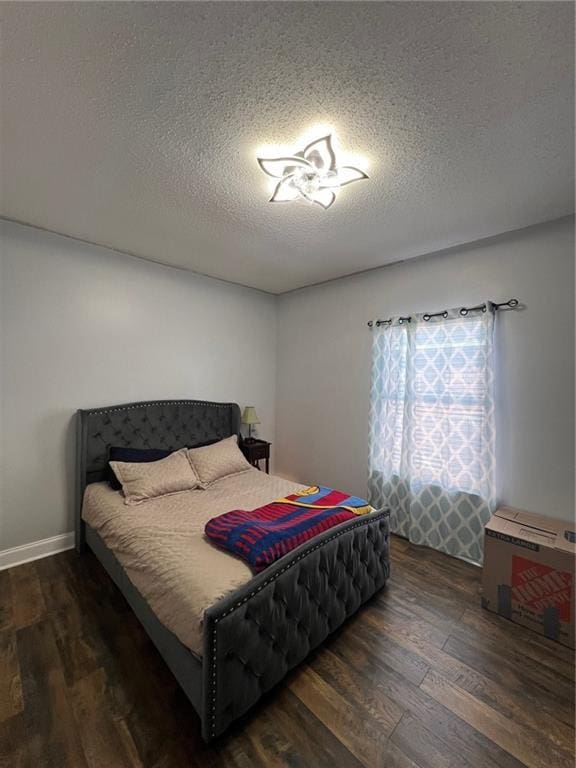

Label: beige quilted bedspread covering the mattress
[82,468,304,657]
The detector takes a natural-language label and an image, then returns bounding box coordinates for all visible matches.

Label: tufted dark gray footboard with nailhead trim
[202,511,389,740]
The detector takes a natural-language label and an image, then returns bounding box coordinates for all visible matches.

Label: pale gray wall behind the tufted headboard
[0,222,276,551]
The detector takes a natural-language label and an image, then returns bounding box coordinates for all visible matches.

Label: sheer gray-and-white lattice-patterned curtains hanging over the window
[369,302,495,563]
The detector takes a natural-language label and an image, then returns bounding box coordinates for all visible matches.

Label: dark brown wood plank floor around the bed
[0,539,574,768]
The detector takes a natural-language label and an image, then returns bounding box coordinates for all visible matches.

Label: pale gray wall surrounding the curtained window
[276,219,574,519]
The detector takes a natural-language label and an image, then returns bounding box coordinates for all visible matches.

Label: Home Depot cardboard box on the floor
[482,507,576,648]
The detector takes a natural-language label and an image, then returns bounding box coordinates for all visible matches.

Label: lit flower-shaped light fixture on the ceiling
[258,135,368,208]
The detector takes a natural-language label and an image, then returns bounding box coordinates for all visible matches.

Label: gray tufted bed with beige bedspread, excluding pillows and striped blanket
[76,400,389,741]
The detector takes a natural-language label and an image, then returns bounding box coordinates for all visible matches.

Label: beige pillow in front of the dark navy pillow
[110,448,202,505]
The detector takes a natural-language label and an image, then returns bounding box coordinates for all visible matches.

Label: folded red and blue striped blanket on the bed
[204,485,373,571]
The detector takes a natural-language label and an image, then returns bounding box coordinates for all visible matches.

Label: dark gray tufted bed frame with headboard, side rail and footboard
[76,400,389,741]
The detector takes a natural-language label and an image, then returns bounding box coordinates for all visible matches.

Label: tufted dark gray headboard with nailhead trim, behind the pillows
[76,400,240,550]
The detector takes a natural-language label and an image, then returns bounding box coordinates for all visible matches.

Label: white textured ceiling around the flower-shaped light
[0,2,574,293]
